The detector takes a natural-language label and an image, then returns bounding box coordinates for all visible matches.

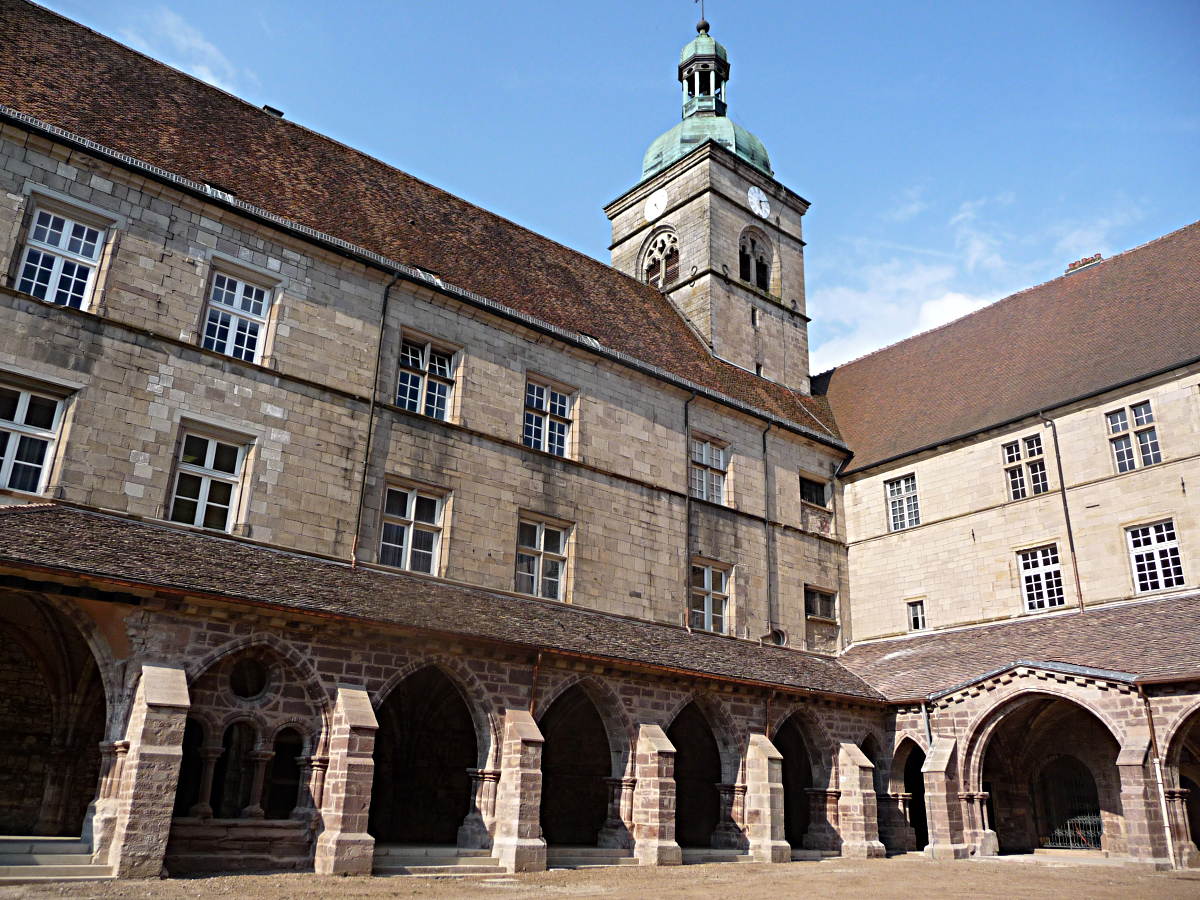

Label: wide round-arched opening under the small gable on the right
[982,695,1126,853]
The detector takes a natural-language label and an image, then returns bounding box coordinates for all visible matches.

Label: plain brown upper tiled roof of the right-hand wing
[814,223,1200,472]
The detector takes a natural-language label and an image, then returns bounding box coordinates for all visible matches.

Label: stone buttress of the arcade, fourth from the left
[632,724,683,865]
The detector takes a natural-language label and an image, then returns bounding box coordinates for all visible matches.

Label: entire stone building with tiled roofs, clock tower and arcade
[0,0,1200,877]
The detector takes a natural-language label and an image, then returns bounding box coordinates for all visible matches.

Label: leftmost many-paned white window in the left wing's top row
[17,208,107,310]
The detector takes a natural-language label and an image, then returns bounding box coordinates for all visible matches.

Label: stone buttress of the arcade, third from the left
[493,709,546,872]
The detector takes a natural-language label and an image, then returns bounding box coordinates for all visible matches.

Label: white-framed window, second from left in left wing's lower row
[169,431,248,532]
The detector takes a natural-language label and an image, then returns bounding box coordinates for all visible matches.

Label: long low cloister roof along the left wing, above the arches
[0,504,880,700]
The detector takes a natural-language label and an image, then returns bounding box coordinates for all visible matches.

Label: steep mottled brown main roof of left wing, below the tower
[0,0,836,437]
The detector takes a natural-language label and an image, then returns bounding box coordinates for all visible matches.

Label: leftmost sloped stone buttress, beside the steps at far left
[108,665,191,878]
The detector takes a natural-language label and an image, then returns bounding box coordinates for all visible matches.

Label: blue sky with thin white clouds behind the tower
[43,0,1200,371]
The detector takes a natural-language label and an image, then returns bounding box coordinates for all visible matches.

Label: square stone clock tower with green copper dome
[605,20,809,394]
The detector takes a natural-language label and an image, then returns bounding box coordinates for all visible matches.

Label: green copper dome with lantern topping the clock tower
[642,20,774,179]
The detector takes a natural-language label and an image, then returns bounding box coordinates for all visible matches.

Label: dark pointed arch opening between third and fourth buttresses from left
[540,685,612,846]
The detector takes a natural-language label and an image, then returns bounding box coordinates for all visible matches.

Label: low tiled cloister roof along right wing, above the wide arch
[839,594,1200,700]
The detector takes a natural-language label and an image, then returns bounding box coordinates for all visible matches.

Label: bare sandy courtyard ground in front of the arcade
[0,858,1200,900]
